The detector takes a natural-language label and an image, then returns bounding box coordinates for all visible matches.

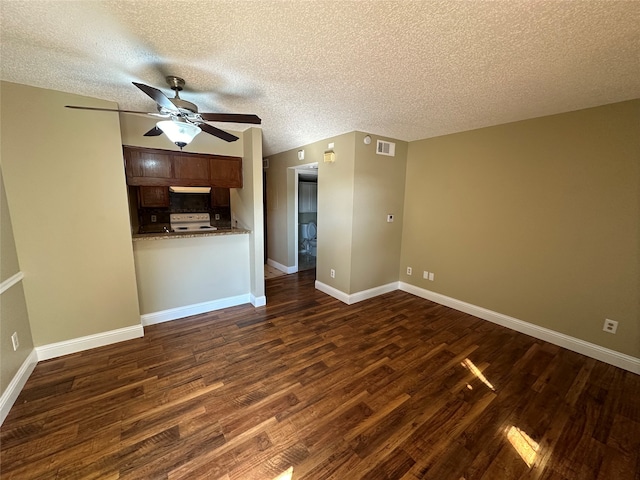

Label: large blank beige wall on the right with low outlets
[400,100,640,357]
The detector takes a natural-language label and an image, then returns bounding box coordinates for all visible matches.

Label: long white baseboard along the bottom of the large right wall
[399,282,640,375]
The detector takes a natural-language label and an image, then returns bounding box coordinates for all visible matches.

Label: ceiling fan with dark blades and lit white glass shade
[65,75,262,150]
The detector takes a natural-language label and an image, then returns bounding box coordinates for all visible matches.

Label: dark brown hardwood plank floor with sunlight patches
[0,271,640,480]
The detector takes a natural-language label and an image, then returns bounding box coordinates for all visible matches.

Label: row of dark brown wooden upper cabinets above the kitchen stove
[123,146,242,188]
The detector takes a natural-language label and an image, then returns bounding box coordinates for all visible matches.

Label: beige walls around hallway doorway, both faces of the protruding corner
[267,132,408,294]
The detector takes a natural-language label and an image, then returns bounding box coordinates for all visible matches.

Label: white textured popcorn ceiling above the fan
[1,0,640,155]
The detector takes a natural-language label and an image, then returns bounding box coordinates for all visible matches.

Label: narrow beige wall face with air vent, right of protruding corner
[349,132,408,293]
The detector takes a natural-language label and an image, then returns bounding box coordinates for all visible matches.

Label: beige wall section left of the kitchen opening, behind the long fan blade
[1,82,140,346]
